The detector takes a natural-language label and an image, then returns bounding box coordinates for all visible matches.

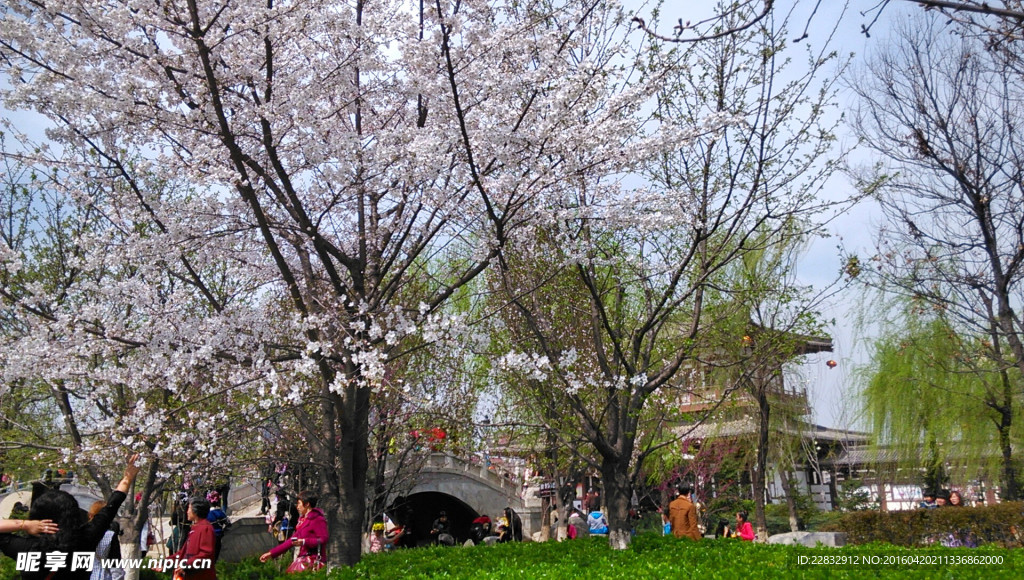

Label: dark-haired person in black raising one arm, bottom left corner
[0,455,138,580]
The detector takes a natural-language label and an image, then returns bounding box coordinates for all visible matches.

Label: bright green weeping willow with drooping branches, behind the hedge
[858,307,1024,500]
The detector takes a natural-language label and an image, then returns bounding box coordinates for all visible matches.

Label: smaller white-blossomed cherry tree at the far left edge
[0,137,282,577]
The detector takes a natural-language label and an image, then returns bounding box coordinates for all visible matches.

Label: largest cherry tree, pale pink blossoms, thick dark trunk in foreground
[0,0,692,564]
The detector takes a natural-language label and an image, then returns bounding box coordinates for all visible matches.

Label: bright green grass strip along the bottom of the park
[0,534,1024,580]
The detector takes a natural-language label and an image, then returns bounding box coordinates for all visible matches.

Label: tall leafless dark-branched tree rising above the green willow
[853,17,1024,504]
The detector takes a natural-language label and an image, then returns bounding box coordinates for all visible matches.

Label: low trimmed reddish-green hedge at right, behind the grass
[823,502,1024,547]
